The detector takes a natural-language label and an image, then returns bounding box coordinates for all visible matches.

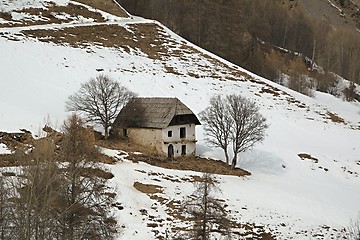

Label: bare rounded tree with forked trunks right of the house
[200,95,268,168]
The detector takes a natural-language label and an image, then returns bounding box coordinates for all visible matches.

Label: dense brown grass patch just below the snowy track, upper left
[22,24,169,56]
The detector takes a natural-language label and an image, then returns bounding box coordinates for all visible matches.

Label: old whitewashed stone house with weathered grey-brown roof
[111,98,200,158]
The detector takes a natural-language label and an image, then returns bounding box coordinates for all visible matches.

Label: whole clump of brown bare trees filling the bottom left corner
[0,115,118,240]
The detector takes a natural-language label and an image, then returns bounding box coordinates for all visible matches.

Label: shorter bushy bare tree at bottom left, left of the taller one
[0,140,61,240]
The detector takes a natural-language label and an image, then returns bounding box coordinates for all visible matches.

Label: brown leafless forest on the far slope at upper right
[119,0,360,100]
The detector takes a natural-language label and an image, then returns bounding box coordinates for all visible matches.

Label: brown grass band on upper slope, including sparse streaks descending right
[22,23,253,83]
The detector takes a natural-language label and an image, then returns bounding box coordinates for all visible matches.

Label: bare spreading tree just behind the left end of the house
[65,75,135,139]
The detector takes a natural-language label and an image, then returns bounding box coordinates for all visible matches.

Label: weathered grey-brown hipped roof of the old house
[113,98,200,129]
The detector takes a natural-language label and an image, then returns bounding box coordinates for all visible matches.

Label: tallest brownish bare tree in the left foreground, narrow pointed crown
[55,115,117,240]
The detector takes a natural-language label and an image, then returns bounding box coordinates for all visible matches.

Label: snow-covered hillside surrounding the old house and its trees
[0,0,360,239]
